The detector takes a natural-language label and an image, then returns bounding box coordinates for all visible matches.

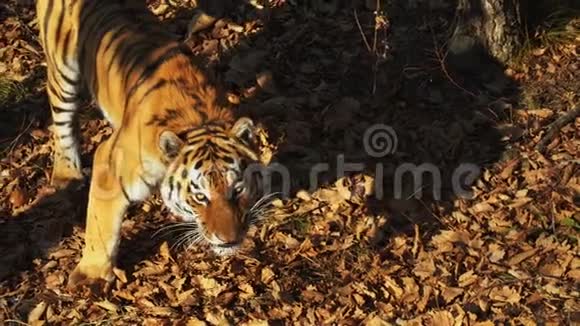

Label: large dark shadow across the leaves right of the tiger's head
[232,3,519,243]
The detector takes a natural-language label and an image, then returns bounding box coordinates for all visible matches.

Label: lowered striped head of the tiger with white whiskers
[159,118,259,255]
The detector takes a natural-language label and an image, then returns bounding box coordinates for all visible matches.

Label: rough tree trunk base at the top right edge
[449,0,522,70]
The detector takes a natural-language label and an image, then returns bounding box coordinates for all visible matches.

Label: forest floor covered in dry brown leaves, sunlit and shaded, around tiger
[0,0,580,325]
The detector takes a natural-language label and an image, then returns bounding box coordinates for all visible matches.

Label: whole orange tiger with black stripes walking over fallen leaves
[36,0,268,287]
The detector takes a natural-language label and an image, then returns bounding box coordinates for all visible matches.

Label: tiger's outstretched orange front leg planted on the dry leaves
[68,137,129,288]
